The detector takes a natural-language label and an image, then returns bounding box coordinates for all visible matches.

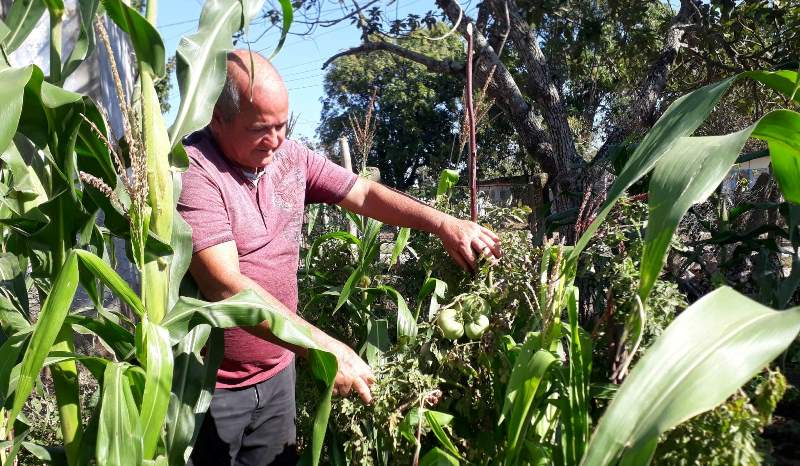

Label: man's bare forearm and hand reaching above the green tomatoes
[338,178,502,271]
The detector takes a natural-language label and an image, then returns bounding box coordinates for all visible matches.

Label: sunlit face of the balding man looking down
[211,86,289,170]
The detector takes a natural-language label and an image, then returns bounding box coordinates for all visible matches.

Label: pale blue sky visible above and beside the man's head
[158,0,435,139]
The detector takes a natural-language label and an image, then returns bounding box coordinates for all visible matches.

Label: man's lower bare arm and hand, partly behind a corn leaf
[189,241,375,403]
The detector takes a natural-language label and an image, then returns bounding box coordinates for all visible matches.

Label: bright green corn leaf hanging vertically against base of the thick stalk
[139,319,173,460]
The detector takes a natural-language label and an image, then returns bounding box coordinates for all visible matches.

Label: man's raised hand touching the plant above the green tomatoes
[436,215,503,272]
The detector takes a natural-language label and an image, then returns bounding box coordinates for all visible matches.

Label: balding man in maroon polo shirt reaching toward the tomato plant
[178,50,500,466]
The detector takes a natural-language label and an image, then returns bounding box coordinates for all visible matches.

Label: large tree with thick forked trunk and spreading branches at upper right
[260,0,798,233]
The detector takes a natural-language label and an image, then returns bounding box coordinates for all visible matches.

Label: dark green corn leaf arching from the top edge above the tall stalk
[103,0,166,76]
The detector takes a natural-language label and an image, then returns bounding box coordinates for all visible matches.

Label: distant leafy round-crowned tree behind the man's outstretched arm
[319,25,463,189]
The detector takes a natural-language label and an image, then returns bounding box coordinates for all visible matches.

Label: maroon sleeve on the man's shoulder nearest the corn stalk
[178,159,234,253]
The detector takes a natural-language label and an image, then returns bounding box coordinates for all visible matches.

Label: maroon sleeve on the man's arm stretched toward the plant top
[298,144,358,204]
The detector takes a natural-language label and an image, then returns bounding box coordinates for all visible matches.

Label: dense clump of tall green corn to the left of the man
[0,0,337,465]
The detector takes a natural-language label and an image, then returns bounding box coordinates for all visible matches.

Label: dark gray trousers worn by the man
[188,361,298,466]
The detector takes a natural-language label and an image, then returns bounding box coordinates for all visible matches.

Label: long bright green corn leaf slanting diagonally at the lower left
[9,252,78,434]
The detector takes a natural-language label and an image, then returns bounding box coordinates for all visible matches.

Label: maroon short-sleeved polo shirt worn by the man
[178,129,357,388]
